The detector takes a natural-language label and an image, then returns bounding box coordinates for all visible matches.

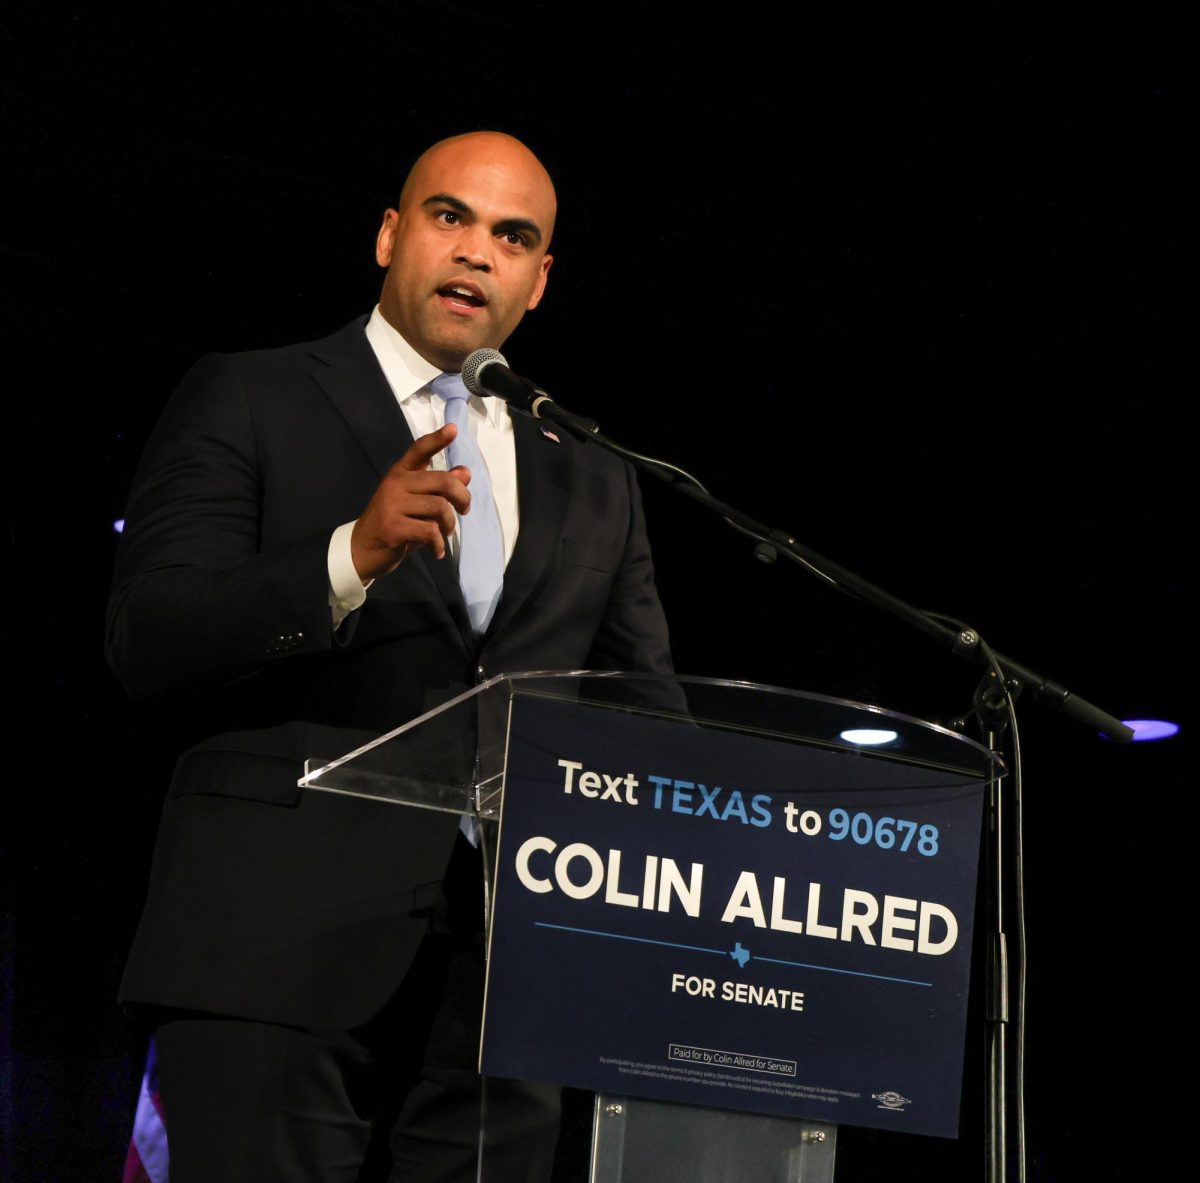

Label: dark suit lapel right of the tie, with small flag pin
[487,413,575,636]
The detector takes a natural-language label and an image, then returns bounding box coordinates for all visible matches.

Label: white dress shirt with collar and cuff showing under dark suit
[328,305,518,629]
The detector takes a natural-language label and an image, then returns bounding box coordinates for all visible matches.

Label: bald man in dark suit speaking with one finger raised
[107,132,671,1183]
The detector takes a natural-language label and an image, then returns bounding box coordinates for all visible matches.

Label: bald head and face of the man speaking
[376,132,556,370]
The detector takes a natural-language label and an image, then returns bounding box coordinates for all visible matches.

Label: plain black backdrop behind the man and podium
[0,0,1195,1183]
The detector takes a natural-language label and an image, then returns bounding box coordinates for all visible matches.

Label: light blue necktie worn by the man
[430,373,504,635]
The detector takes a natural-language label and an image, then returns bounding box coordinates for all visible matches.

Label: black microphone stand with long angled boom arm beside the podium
[525,390,1134,1183]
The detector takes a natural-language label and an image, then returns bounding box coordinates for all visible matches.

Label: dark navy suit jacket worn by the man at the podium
[108,320,671,1027]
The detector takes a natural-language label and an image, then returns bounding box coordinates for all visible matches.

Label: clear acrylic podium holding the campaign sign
[300,671,1001,1183]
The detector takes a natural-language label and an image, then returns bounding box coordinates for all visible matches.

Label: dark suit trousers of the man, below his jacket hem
[155,835,559,1183]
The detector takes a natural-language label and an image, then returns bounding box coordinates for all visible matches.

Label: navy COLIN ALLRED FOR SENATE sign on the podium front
[481,695,983,1137]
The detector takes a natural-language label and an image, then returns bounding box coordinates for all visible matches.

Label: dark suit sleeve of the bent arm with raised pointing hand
[107,356,334,697]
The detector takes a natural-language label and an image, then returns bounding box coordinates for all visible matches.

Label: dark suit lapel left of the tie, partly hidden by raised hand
[304,320,476,650]
